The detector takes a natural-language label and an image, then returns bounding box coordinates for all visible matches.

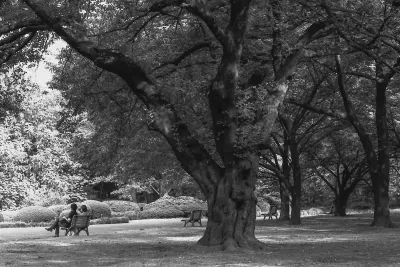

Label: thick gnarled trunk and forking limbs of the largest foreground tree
[1,0,329,249]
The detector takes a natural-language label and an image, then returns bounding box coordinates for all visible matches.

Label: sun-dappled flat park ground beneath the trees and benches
[0,215,400,267]
